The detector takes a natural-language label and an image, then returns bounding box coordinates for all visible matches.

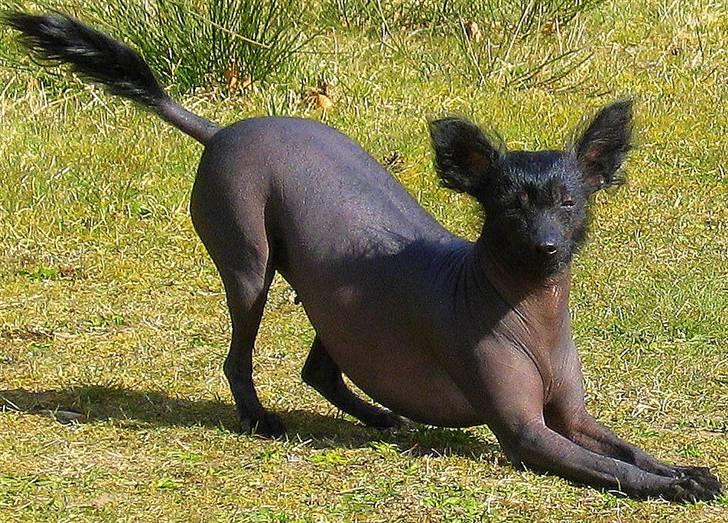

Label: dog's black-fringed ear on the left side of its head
[430,118,505,198]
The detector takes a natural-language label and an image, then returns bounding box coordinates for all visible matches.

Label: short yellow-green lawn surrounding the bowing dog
[0,0,728,522]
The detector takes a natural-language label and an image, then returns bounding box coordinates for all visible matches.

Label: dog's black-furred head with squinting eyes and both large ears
[430,100,632,276]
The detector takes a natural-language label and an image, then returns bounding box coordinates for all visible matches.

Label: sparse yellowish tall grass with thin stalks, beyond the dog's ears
[323,0,604,89]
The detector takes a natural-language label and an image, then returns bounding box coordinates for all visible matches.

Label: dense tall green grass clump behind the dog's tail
[19,0,308,93]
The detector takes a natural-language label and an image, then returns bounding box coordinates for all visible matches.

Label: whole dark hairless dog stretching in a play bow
[5,13,721,501]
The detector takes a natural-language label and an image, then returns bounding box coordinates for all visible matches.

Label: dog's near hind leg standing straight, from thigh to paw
[190,161,285,437]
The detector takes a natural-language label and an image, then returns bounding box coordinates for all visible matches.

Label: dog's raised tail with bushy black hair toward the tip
[3,12,220,144]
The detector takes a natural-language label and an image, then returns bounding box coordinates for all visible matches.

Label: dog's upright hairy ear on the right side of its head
[574,100,632,194]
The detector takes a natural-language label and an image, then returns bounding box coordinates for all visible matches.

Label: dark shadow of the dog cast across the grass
[0,384,503,462]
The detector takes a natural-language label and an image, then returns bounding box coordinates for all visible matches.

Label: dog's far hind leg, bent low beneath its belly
[301,335,402,428]
